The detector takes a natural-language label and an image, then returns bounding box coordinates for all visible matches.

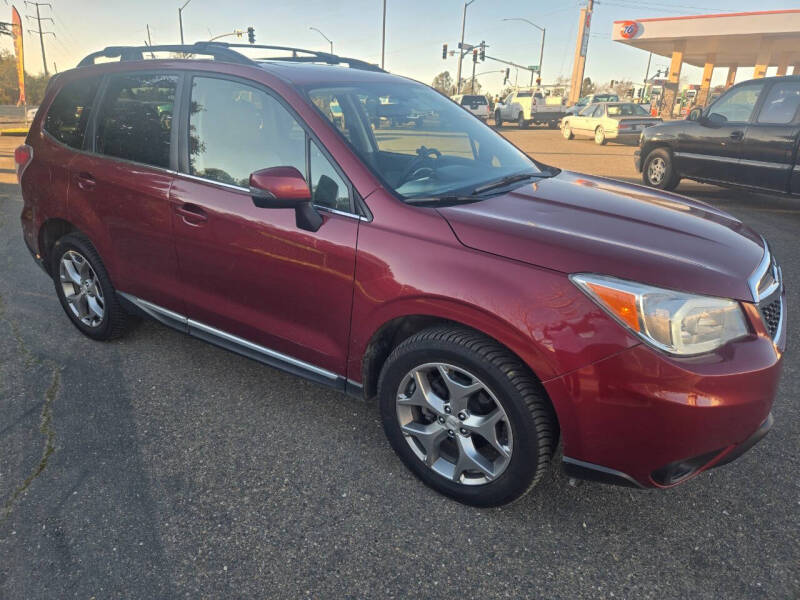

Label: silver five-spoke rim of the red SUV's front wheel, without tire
[396,363,513,485]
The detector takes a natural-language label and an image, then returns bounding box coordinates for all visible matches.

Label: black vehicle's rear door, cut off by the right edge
[735,80,800,192]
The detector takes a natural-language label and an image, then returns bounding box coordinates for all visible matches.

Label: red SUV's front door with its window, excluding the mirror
[170,76,359,375]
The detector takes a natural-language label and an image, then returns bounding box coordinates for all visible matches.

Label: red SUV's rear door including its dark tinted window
[69,71,183,312]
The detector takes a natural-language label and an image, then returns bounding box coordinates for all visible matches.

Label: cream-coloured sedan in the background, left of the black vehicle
[561,102,661,145]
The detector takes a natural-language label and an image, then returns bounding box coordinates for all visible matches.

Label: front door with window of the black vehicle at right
[675,80,764,182]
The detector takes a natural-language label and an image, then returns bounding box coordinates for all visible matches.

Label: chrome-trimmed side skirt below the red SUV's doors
[117,292,354,398]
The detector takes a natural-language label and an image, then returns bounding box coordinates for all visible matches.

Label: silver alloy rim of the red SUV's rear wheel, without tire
[59,250,106,327]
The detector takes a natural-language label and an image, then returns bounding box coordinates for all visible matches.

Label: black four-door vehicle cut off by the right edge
[634,75,800,195]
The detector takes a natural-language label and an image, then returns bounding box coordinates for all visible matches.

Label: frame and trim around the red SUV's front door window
[181,71,360,220]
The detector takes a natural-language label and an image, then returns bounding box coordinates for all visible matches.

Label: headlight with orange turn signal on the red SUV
[570,274,748,356]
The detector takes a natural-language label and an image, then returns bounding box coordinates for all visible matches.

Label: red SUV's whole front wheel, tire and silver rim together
[378,326,558,506]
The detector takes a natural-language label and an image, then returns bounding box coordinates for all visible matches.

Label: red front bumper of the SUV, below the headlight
[544,324,785,487]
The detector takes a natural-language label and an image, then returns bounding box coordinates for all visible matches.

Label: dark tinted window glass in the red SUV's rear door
[96,73,178,169]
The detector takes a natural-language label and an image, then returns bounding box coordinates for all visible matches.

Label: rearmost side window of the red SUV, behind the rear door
[44,78,100,149]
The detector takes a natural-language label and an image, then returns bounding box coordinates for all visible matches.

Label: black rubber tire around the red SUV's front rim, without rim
[378,326,558,506]
